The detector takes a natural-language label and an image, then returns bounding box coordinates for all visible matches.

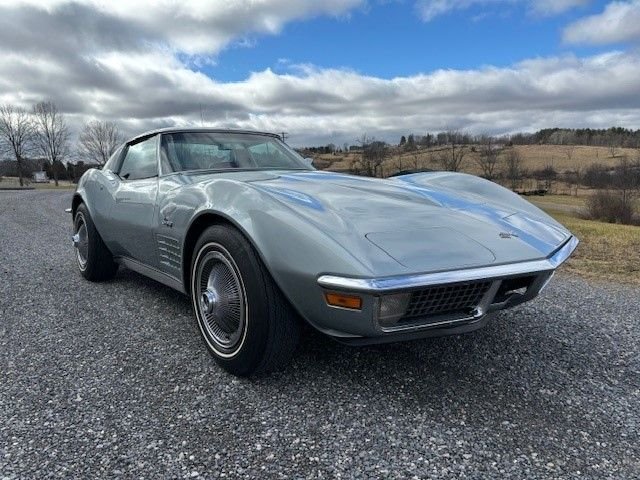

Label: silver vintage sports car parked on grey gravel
[71,129,578,375]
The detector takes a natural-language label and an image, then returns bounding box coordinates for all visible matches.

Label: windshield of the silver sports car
[160,132,311,173]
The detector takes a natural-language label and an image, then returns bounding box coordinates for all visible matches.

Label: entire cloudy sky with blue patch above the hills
[0,0,640,145]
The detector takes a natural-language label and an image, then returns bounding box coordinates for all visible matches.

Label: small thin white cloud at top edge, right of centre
[416,0,590,22]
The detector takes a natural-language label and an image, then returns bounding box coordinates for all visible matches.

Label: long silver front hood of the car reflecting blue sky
[248,172,570,274]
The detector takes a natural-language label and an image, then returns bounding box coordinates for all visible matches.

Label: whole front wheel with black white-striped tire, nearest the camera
[190,225,300,376]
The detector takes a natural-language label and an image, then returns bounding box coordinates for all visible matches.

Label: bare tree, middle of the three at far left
[33,101,69,186]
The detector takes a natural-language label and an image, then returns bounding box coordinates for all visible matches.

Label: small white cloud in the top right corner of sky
[563,0,640,45]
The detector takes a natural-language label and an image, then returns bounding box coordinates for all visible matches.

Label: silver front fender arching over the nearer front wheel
[159,179,388,327]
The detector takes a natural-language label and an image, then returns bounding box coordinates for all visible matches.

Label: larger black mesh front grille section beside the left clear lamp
[400,281,491,322]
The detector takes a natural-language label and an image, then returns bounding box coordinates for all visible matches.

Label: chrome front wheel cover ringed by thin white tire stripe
[193,244,247,356]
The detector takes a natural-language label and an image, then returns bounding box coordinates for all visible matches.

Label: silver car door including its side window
[110,135,158,267]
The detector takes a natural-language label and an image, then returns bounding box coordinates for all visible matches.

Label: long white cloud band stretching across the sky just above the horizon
[0,45,640,143]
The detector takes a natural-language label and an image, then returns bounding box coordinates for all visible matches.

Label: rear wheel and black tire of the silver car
[73,203,118,282]
